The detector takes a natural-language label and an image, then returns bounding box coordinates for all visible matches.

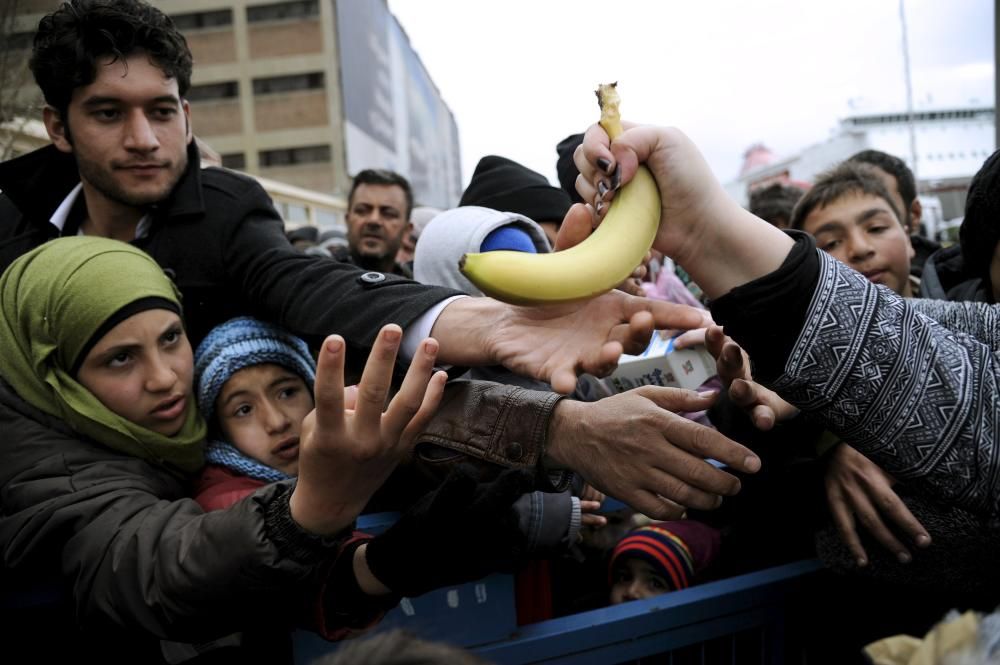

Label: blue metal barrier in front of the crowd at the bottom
[293,506,822,665]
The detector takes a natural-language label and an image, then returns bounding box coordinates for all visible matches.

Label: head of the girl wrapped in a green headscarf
[0,236,205,472]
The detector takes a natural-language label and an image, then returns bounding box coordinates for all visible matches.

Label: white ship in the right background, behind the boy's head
[726,106,996,226]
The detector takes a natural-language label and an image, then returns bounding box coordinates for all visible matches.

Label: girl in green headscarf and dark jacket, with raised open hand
[0,236,460,663]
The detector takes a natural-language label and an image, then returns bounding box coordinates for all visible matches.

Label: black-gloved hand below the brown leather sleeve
[365,466,534,597]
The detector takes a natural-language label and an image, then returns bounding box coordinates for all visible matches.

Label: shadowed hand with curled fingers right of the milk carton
[705,325,799,432]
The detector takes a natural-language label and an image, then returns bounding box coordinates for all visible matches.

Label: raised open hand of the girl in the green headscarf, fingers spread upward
[289,324,447,535]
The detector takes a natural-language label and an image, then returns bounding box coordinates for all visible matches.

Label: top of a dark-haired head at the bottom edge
[313,628,486,665]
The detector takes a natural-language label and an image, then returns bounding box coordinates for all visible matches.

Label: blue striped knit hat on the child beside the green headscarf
[194,316,316,423]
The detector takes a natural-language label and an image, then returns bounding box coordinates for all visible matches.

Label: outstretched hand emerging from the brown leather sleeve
[547,386,760,519]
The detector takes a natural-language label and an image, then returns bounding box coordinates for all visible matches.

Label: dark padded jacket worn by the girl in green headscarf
[0,381,384,663]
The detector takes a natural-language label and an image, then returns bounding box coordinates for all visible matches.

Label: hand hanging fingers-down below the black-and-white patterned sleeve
[825,443,931,566]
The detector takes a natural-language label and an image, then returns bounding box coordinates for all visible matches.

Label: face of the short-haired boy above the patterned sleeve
[802,194,913,298]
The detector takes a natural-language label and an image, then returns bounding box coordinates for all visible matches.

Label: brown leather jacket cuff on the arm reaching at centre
[414,379,572,491]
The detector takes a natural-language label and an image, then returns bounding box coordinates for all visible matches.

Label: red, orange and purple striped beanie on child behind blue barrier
[608,520,720,591]
